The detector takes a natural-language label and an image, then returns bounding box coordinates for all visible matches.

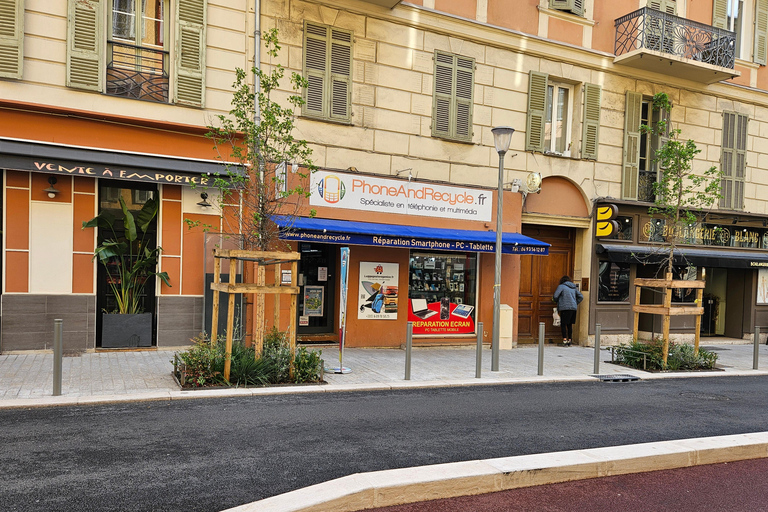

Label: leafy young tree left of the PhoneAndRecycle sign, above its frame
[209,28,316,251]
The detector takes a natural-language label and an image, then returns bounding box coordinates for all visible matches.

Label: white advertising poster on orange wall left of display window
[357,261,400,320]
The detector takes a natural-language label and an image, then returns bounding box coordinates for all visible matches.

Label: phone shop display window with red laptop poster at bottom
[408,252,477,335]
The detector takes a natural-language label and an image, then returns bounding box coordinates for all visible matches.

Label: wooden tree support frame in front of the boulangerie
[632,274,706,365]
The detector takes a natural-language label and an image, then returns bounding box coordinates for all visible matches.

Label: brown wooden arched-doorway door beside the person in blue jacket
[517,225,575,343]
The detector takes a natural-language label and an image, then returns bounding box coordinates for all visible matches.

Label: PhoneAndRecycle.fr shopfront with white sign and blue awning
[284,170,548,347]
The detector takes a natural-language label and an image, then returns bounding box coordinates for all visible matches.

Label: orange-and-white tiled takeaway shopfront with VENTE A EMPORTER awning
[0,111,228,353]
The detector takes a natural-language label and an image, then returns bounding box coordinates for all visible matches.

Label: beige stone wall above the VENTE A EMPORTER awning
[0,0,249,126]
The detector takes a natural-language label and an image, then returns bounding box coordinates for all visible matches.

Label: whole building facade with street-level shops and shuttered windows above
[0,0,768,351]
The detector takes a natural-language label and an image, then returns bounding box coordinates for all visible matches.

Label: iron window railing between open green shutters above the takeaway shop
[107,41,168,103]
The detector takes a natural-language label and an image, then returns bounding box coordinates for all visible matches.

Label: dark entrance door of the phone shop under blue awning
[297,242,339,336]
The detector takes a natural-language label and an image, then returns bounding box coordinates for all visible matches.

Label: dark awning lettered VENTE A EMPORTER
[0,138,243,185]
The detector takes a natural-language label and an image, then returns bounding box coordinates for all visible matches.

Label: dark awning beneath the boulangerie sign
[595,244,768,268]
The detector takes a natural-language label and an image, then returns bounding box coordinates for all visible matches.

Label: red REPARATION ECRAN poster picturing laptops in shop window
[408,297,475,335]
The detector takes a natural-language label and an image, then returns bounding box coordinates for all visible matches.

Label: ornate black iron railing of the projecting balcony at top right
[614,7,736,69]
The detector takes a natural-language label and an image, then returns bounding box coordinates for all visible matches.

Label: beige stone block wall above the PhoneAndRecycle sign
[262,0,768,217]
